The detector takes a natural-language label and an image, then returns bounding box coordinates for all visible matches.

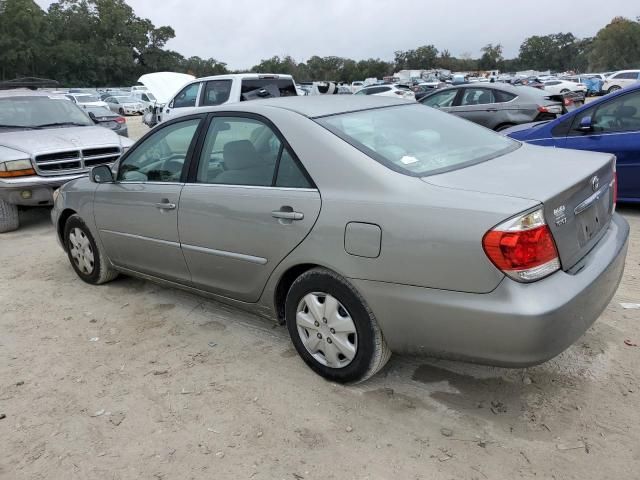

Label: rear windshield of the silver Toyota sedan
[316,105,520,177]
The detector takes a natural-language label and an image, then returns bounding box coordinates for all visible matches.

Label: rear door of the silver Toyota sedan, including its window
[178,113,321,302]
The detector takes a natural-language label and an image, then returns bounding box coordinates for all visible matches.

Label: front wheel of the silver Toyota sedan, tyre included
[64,215,118,285]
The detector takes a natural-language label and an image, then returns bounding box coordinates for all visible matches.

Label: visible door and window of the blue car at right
[562,90,640,199]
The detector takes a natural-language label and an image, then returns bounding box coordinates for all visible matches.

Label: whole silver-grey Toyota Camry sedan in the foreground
[53,96,629,382]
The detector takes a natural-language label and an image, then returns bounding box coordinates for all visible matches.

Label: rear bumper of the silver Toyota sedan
[352,214,629,367]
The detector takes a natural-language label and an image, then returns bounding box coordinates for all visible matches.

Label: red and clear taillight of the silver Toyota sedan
[482,210,560,282]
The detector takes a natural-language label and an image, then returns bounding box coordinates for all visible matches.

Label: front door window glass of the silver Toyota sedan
[117,119,200,182]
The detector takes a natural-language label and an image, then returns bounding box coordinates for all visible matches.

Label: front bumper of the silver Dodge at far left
[0,173,87,206]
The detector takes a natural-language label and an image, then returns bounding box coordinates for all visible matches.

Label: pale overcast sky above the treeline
[36,0,640,69]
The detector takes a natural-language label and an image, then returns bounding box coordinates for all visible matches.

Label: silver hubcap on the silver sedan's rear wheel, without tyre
[296,292,358,368]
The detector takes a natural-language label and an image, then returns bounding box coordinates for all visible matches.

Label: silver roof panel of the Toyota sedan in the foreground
[191,95,410,118]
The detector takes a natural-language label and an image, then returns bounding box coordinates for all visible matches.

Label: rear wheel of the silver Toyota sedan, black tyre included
[285,268,391,383]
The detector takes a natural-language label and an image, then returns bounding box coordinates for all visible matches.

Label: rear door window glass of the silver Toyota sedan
[197,117,309,188]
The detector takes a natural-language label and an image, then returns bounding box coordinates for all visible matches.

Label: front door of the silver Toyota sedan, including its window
[94,116,203,284]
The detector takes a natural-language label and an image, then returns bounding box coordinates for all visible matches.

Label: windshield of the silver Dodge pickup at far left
[0,97,93,128]
